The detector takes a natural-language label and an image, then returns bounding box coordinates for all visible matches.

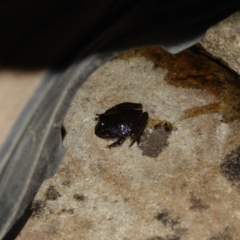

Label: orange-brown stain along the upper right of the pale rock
[119,46,240,122]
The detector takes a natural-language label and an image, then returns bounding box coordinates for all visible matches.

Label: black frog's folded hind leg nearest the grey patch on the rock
[129,112,148,147]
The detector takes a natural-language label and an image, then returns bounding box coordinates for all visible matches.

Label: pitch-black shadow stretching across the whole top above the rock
[0,0,240,70]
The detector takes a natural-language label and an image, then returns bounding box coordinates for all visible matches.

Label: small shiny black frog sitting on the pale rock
[95,102,148,148]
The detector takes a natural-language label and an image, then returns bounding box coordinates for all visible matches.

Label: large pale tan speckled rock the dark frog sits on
[17,11,240,240]
